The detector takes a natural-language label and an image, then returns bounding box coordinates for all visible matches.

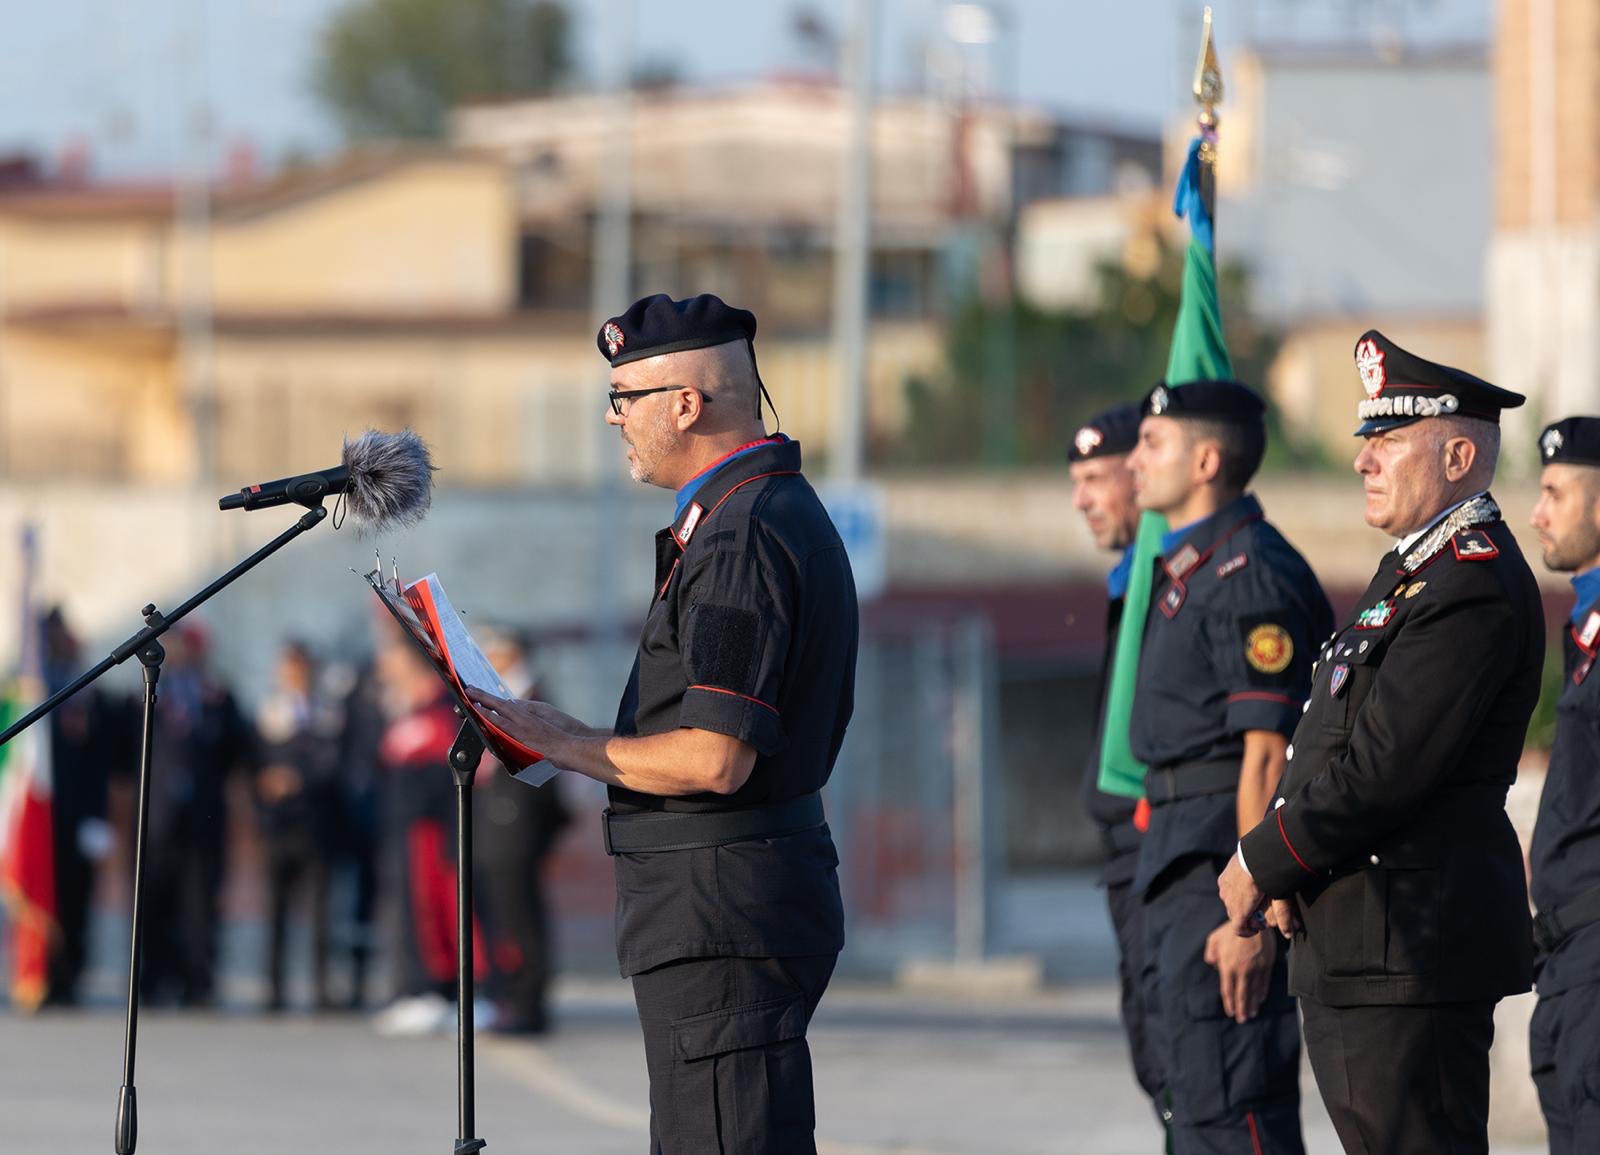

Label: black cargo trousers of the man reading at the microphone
[634,955,838,1155]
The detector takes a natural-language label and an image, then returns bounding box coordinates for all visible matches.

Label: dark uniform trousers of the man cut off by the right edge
[1528,982,1600,1155]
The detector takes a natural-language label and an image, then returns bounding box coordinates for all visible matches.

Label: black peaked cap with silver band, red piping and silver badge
[1355,330,1526,437]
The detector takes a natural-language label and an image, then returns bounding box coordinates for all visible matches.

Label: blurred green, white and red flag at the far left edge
[0,526,58,1011]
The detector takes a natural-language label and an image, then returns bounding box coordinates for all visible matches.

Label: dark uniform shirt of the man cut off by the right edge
[1528,601,1600,995]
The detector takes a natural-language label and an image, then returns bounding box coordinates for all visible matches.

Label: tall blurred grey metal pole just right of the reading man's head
[830,0,877,482]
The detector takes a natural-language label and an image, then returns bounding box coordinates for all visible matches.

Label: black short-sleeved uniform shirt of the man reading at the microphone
[610,437,858,976]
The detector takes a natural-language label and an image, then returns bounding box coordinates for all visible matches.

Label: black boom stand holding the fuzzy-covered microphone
[0,498,329,1155]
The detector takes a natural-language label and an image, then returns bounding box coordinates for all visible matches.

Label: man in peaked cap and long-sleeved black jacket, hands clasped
[1218,331,1544,1155]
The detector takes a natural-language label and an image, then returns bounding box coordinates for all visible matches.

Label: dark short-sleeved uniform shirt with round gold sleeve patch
[1130,494,1333,893]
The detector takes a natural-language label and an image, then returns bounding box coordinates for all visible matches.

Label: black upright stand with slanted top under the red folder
[366,571,488,1155]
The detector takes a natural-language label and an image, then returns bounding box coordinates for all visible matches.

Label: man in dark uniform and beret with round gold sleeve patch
[1128,381,1333,1155]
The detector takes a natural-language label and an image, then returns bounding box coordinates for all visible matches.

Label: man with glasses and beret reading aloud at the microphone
[475,294,858,1155]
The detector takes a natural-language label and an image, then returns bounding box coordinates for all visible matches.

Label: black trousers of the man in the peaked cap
[1301,998,1494,1155]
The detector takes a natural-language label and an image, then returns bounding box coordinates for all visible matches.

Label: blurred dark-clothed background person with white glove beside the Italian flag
[43,606,126,1006]
